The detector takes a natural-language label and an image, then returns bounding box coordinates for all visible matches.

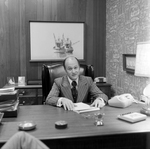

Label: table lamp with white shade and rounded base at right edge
[135,42,150,114]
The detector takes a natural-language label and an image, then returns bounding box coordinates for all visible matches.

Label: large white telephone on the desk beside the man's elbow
[108,93,135,108]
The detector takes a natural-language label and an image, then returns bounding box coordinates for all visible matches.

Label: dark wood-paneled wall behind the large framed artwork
[0,0,106,87]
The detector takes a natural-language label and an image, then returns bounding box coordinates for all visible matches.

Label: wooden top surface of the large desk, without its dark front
[0,104,150,143]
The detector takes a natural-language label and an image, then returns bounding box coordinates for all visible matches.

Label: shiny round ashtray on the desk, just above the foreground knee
[18,121,36,130]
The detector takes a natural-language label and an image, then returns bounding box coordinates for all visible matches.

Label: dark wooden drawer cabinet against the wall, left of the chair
[4,83,42,105]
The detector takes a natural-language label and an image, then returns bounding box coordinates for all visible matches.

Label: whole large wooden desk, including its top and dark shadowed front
[0,105,150,149]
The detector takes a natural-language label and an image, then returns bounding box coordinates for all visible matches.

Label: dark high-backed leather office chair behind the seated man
[42,64,94,103]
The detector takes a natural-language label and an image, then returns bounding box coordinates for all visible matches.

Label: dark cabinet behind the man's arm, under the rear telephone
[96,83,112,99]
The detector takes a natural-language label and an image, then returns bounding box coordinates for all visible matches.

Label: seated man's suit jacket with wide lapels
[46,75,108,105]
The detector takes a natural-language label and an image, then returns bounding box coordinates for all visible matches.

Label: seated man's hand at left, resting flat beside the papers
[61,98,74,110]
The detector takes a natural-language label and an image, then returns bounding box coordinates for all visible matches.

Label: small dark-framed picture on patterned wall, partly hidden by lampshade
[123,54,136,74]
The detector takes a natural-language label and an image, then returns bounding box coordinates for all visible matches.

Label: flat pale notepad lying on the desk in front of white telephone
[118,112,147,123]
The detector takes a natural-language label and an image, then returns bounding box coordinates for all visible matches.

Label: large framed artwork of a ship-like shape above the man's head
[29,21,85,62]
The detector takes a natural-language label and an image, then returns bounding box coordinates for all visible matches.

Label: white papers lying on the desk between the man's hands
[73,102,100,113]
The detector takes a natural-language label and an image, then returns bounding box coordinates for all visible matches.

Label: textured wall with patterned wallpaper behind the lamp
[106,0,150,99]
